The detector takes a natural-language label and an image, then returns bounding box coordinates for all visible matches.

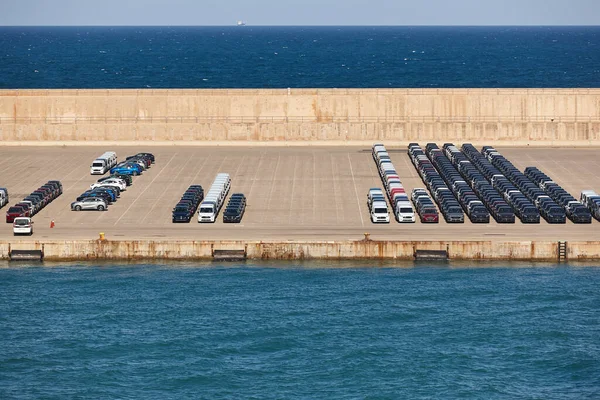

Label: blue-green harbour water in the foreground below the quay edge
[0,263,600,399]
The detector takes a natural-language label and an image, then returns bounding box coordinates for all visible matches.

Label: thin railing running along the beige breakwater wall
[0,116,600,124]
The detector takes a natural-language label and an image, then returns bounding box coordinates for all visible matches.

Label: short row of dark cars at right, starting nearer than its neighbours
[524,167,592,224]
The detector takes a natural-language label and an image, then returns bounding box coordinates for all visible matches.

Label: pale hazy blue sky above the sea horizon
[0,0,600,25]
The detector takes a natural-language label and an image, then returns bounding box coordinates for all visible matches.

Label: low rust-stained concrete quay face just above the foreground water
[0,240,600,261]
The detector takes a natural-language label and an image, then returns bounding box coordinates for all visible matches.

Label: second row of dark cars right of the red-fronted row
[425,143,490,223]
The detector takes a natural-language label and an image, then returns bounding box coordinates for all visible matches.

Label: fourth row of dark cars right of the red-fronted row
[461,143,540,224]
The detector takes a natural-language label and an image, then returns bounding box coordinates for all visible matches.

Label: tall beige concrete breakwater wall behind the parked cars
[0,89,600,145]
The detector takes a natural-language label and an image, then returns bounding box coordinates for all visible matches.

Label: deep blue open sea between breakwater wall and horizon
[0,26,600,88]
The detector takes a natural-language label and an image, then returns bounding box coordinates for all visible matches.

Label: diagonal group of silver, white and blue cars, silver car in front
[71,152,154,211]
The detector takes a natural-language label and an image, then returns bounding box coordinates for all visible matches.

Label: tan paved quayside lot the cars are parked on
[0,143,600,240]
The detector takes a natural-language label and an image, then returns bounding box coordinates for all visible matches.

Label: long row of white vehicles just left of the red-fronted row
[370,143,415,222]
